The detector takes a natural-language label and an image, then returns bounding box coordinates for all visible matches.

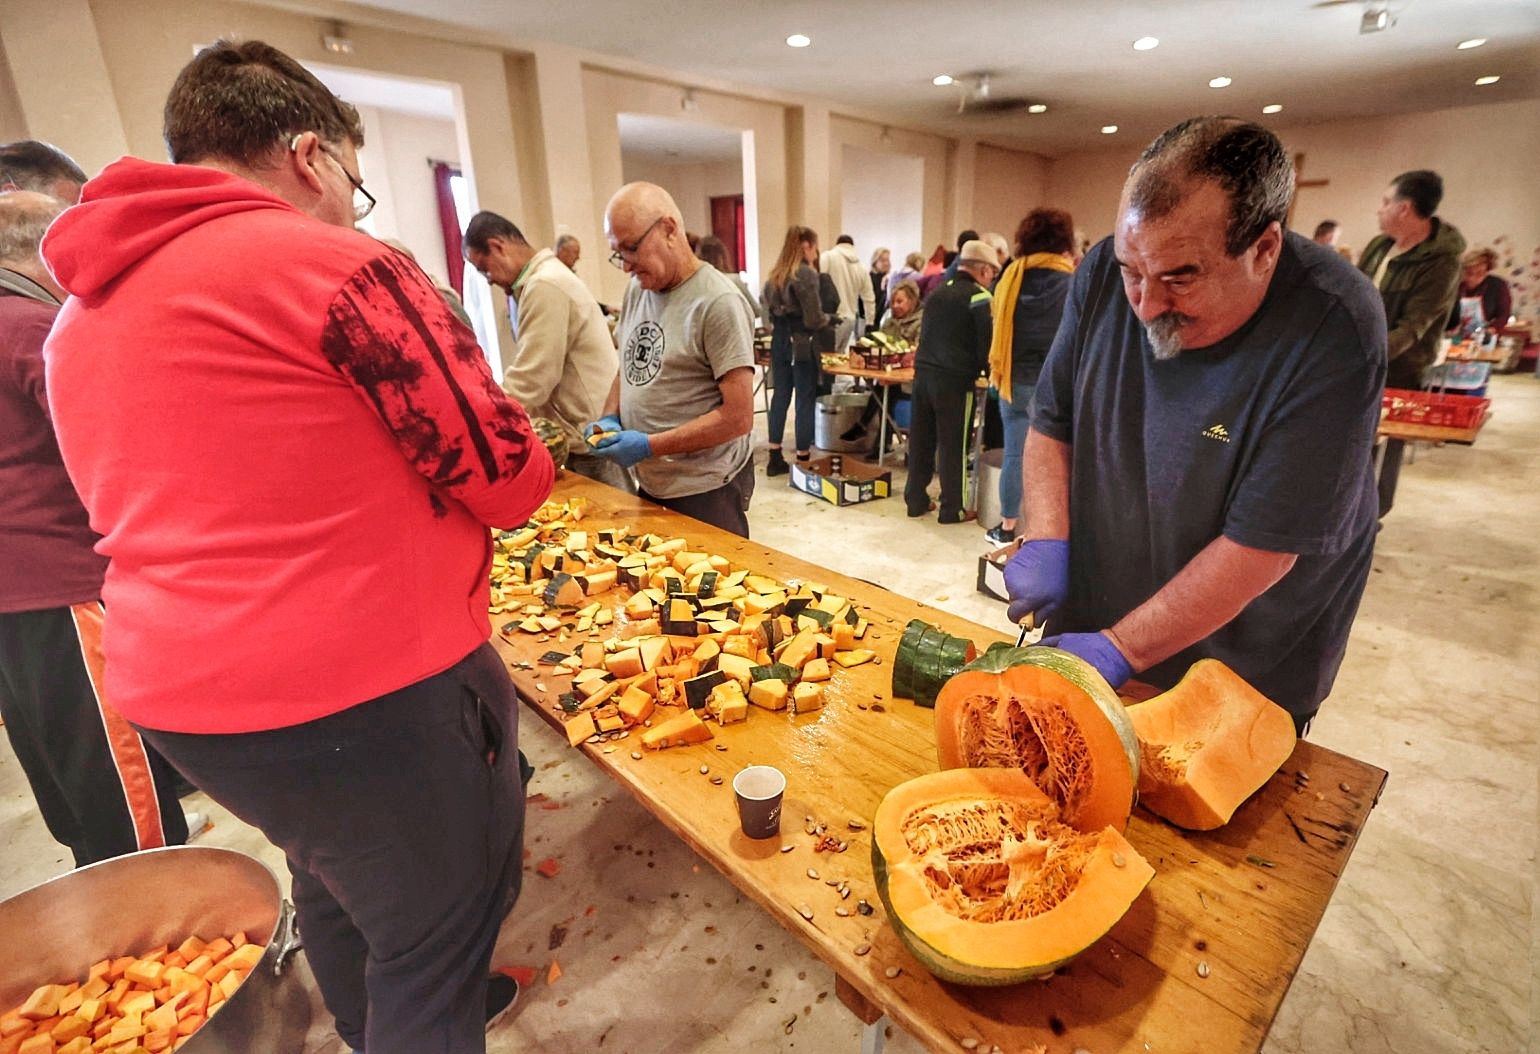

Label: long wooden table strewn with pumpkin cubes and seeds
[493,473,1386,1054]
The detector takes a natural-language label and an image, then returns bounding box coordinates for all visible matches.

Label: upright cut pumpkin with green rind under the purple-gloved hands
[936,647,1140,831]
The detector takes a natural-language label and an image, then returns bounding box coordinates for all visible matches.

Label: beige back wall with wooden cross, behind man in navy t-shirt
[1046,100,1540,260]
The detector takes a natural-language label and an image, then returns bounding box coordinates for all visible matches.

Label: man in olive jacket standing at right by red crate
[1358,170,1465,519]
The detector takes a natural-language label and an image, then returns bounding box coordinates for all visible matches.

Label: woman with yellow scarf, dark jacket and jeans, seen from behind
[986,208,1075,545]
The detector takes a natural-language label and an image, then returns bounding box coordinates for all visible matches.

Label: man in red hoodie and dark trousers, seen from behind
[43,42,554,1054]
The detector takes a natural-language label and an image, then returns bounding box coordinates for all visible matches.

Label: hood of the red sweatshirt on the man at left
[43,157,302,299]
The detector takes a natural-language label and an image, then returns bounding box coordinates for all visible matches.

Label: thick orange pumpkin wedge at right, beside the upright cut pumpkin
[1129,660,1295,831]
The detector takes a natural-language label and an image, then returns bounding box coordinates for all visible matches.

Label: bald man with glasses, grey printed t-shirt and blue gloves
[587,183,755,538]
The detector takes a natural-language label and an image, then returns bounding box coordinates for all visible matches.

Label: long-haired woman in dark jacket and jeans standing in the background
[764,227,829,476]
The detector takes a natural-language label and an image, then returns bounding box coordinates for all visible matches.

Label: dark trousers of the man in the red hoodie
[145,644,525,1054]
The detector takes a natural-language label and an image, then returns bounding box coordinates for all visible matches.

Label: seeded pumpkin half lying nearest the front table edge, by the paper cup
[872,769,1155,985]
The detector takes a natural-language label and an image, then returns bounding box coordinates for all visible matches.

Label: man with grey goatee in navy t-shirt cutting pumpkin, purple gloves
[1006,110,1386,730]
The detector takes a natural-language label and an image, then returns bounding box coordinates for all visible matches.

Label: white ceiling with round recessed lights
[346,0,1540,156]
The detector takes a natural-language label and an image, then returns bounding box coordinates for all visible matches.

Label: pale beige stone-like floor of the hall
[0,376,1540,1054]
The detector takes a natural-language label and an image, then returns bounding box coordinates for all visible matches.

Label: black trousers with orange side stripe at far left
[0,604,188,868]
